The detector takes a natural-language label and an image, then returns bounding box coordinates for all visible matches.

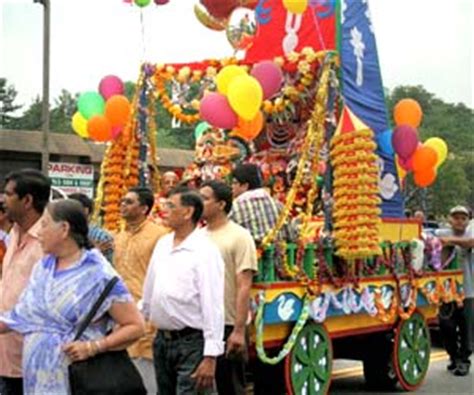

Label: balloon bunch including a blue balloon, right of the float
[378,99,448,188]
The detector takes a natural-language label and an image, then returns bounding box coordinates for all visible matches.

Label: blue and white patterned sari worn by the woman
[0,250,132,395]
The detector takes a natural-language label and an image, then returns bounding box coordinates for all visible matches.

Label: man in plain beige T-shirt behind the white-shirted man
[200,181,258,395]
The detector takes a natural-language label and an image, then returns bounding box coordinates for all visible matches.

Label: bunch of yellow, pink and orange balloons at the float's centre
[200,61,283,141]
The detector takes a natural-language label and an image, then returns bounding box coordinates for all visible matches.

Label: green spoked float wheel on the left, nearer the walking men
[285,322,332,395]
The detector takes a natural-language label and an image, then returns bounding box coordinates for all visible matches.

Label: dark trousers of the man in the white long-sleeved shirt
[153,331,211,395]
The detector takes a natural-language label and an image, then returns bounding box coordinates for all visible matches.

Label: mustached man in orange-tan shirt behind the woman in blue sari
[114,187,168,394]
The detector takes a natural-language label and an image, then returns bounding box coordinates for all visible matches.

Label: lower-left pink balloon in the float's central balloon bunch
[200,93,238,129]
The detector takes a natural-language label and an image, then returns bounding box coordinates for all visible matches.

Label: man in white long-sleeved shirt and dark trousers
[143,188,224,395]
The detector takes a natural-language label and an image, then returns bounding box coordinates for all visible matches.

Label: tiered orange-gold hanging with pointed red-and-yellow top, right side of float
[331,106,382,262]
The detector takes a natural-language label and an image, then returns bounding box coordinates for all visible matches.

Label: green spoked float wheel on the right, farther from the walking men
[393,312,431,391]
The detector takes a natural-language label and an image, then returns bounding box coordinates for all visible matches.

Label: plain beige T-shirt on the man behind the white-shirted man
[206,221,258,325]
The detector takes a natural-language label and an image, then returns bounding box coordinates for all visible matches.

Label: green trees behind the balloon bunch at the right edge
[387,86,474,217]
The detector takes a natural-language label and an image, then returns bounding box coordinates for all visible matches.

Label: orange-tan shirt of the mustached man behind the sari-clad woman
[114,220,168,359]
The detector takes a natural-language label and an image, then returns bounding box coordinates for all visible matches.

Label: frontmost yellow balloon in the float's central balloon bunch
[227,74,263,121]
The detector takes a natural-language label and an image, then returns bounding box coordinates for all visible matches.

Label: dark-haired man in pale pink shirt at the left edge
[0,169,51,395]
